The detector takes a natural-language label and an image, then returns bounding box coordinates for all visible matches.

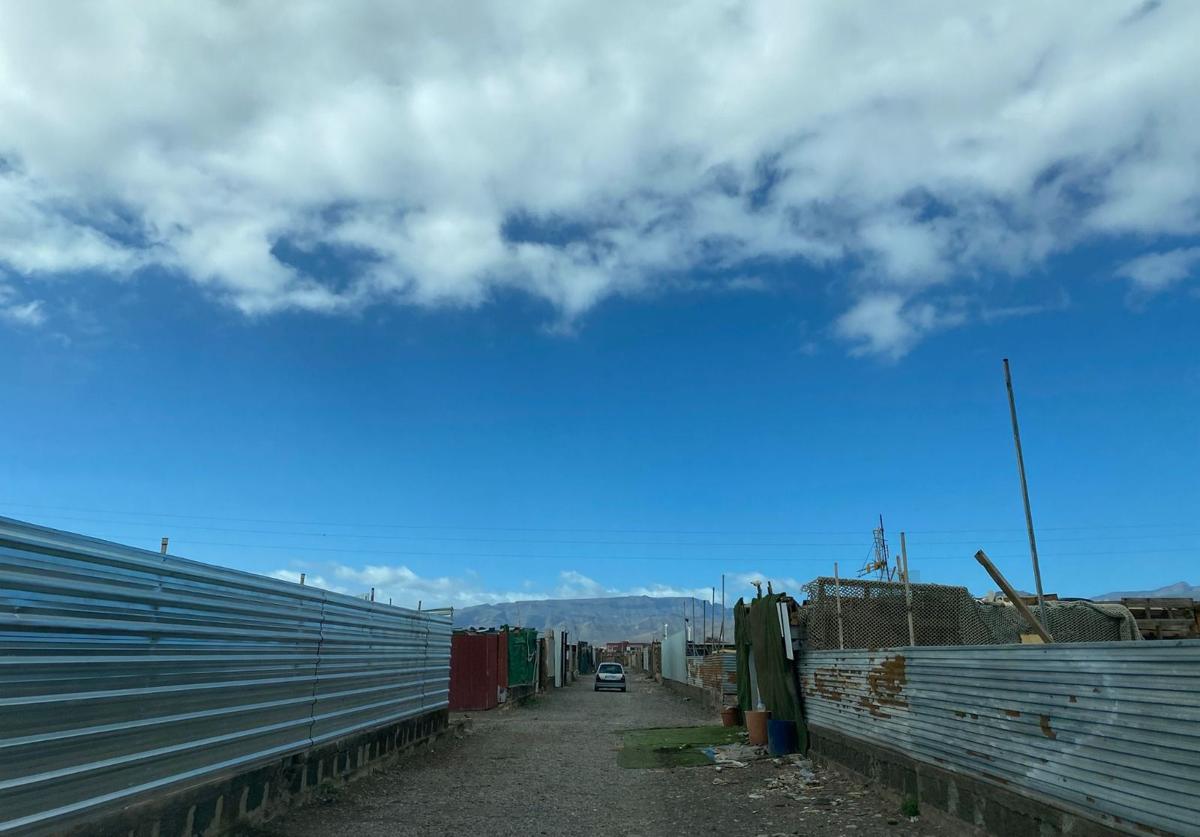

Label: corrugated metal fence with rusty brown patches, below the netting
[802,640,1200,835]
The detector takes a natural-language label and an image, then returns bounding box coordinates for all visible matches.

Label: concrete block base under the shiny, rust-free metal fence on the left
[71,709,449,837]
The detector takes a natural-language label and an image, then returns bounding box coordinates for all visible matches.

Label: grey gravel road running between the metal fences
[242,675,973,837]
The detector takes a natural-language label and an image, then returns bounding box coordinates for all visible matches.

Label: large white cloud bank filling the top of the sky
[0,0,1200,356]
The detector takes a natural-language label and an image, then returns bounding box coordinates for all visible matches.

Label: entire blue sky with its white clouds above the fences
[0,2,1200,606]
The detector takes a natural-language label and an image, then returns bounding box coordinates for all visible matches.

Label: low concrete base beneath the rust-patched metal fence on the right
[809,725,1126,837]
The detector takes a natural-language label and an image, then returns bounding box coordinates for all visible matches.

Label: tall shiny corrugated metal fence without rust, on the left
[0,518,450,832]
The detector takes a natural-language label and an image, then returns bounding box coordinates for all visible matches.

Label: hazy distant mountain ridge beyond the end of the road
[454,596,733,643]
